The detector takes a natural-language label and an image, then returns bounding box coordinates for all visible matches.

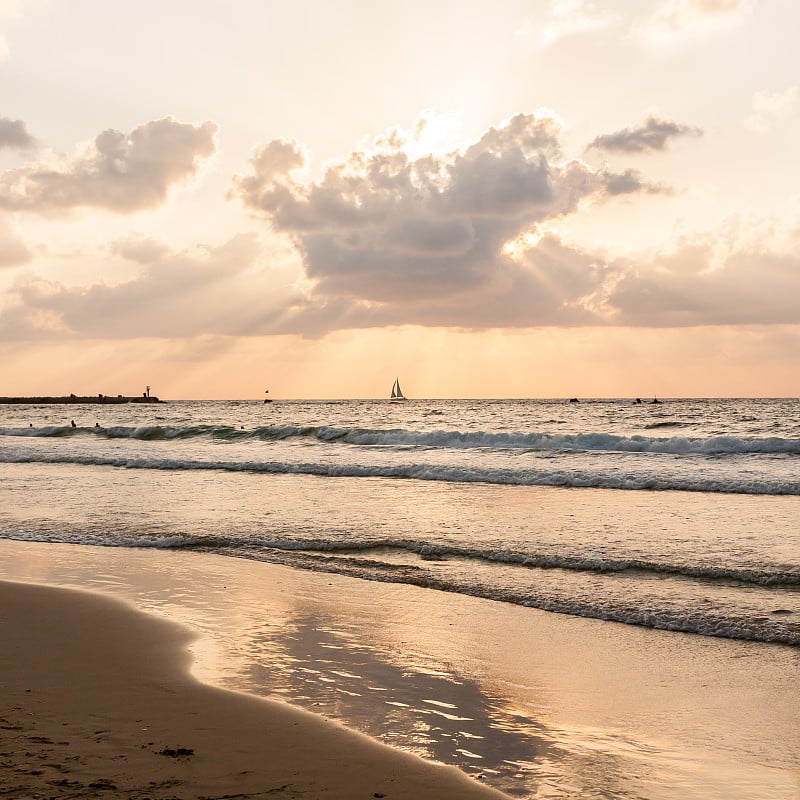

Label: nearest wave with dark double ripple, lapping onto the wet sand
[0,532,800,647]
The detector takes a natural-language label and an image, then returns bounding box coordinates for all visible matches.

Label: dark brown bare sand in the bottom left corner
[0,581,505,800]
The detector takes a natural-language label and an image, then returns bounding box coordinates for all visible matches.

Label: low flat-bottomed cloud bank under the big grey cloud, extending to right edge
[281,222,800,335]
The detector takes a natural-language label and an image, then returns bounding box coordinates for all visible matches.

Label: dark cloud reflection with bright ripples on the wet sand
[238,615,554,794]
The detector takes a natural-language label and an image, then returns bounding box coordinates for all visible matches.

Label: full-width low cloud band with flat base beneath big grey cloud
[0,223,800,342]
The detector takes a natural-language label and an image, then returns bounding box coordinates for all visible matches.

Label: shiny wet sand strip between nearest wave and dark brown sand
[0,540,800,800]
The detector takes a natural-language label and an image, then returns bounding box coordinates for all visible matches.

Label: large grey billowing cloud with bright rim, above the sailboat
[231,113,659,304]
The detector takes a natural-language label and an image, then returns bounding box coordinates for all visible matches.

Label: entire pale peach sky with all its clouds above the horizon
[0,0,800,399]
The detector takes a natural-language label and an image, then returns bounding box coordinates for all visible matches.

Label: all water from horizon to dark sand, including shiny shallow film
[0,399,800,800]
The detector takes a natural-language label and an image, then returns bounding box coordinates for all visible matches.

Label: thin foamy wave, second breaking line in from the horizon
[0,451,800,495]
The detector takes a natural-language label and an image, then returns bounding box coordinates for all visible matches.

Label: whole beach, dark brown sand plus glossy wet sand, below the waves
[0,540,800,800]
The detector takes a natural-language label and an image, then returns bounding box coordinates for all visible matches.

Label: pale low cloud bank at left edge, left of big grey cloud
[0,234,300,341]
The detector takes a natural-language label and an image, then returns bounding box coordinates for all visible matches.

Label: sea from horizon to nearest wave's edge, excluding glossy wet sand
[0,399,800,647]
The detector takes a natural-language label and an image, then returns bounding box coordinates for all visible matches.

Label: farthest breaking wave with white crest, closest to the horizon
[0,422,800,456]
